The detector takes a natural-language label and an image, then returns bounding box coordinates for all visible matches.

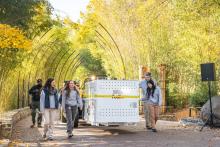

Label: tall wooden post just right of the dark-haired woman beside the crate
[159,64,166,113]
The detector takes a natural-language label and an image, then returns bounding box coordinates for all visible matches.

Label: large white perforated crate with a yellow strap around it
[84,80,139,126]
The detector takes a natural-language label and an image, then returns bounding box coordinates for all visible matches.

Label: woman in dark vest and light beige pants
[40,78,59,140]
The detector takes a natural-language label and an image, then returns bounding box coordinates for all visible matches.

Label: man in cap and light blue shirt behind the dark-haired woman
[139,72,156,129]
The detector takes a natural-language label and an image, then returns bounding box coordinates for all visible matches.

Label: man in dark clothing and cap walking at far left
[28,79,42,128]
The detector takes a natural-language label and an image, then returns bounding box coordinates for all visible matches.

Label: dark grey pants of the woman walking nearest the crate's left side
[65,105,78,134]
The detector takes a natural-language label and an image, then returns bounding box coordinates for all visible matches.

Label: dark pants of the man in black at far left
[31,101,42,125]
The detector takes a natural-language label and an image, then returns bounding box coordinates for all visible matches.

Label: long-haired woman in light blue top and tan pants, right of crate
[146,80,162,132]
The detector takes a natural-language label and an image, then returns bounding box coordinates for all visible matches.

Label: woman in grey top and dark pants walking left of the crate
[62,81,83,137]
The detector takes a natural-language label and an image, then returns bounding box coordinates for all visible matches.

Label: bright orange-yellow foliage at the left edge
[0,24,31,50]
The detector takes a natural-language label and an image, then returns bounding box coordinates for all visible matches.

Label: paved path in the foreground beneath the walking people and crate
[0,117,220,147]
